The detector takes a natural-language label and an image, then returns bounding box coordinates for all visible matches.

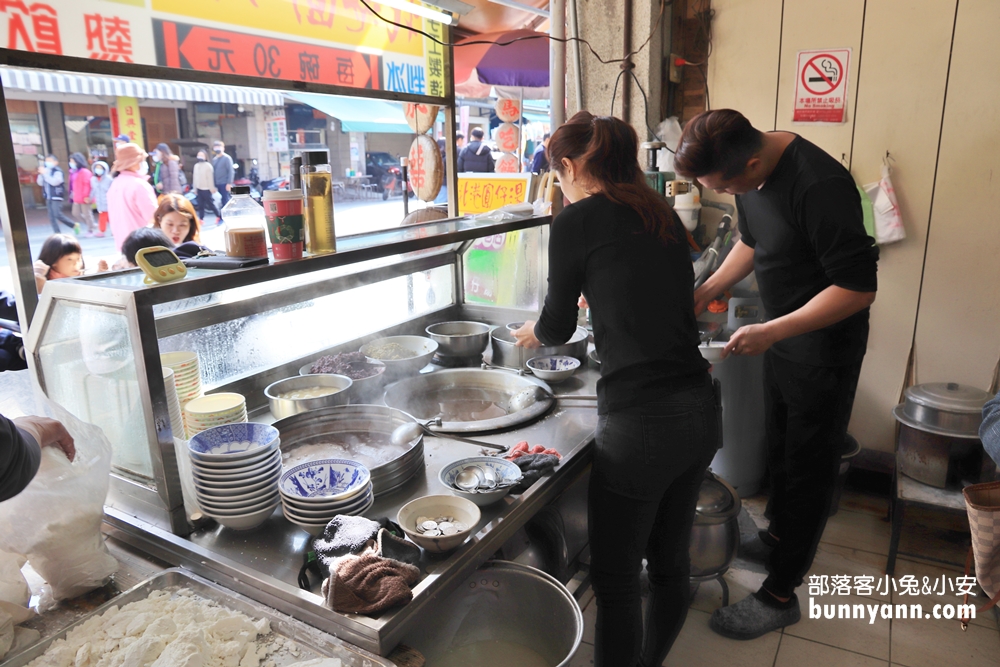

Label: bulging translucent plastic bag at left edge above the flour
[0,371,118,609]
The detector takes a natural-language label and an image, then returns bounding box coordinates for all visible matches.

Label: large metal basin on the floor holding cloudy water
[403,561,583,667]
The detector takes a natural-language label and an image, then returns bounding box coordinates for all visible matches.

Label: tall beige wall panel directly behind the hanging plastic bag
[851,0,956,452]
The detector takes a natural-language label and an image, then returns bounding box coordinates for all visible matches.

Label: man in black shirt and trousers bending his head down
[675,109,878,639]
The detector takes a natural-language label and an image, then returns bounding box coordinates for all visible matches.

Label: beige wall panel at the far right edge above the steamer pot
[916,0,1000,389]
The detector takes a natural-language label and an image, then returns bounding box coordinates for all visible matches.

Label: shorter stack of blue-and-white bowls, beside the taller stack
[278,459,375,535]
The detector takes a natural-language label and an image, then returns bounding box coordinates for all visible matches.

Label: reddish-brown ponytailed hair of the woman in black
[547,111,679,243]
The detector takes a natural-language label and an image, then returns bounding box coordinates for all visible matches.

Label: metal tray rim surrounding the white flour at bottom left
[3,568,395,667]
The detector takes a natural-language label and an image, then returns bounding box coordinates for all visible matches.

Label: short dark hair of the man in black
[674,109,764,179]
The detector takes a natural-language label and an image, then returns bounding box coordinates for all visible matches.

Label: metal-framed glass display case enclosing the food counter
[26,217,550,535]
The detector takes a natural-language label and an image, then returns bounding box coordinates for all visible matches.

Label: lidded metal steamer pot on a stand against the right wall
[892,382,996,489]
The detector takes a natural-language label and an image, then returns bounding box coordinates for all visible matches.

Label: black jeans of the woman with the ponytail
[589,374,719,667]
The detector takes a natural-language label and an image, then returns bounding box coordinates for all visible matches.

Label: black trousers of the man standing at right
[764,351,861,597]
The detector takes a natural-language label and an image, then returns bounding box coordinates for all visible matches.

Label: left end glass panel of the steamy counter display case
[38,300,153,482]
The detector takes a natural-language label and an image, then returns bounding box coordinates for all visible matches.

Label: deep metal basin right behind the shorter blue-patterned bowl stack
[274,405,424,496]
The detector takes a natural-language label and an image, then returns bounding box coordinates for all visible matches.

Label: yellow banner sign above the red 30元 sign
[152,0,424,57]
